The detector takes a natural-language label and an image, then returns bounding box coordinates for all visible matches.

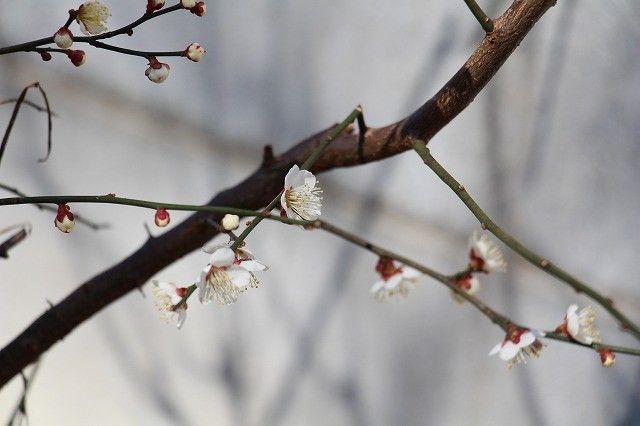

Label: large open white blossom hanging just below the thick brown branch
[197,244,267,305]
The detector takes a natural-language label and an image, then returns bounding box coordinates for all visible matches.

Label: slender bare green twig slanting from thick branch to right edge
[413,140,640,340]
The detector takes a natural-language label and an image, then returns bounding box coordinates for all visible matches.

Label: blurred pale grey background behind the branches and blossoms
[0,0,640,425]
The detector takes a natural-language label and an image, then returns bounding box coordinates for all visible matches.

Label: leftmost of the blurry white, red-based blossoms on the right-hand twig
[371,256,421,302]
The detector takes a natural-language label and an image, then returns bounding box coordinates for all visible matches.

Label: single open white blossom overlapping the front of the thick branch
[280,164,322,220]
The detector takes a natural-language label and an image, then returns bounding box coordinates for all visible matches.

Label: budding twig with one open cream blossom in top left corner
[39,0,207,83]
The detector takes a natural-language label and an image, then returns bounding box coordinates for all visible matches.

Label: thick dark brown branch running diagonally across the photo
[0,0,555,387]
